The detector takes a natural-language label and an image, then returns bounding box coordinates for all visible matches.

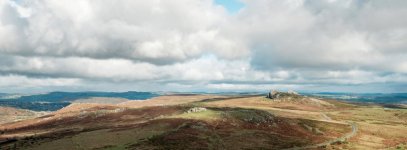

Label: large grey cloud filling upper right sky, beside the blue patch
[236,1,407,72]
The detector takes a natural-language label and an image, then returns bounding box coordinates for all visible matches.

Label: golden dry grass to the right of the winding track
[330,106,407,149]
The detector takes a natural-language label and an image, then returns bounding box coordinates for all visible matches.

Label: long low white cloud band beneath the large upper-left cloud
[0,55,269,82]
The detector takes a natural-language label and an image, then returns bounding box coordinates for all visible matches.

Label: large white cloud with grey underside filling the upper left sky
[0,0,244,65]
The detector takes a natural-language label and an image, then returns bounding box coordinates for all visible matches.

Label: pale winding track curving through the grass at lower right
[284,113,358,150]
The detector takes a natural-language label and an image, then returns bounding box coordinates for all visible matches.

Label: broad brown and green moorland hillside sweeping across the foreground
[0,96,407,149]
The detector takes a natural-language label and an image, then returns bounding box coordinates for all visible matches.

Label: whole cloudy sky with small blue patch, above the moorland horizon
[0,0,407,93]
